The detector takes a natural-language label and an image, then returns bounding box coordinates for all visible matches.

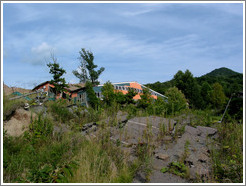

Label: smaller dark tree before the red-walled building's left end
[47,55,68,95]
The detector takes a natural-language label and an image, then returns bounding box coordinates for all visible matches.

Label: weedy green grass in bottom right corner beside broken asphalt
[212,121,243,183]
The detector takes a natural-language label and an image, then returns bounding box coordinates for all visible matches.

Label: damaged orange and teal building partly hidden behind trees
[32,81,167,106]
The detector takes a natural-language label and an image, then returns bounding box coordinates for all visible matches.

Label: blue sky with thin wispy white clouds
[3,3,243,88]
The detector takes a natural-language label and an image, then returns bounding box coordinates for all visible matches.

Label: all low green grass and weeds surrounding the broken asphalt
[3,91,243,183]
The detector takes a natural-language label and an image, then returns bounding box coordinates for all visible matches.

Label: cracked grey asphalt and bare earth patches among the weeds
[4,106,217,183]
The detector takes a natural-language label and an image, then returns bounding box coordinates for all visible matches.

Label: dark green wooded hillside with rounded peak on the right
[146,67,243,119]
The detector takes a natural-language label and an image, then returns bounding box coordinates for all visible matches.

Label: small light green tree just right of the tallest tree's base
[102,81,115,106]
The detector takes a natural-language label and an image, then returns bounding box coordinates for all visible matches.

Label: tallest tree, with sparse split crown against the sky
[73,48,105,86]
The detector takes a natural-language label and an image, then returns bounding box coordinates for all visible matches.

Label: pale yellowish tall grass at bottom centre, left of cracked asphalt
[69,139,134,183]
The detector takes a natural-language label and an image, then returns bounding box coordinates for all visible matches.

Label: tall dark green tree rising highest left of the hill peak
[174,70,201,108]
